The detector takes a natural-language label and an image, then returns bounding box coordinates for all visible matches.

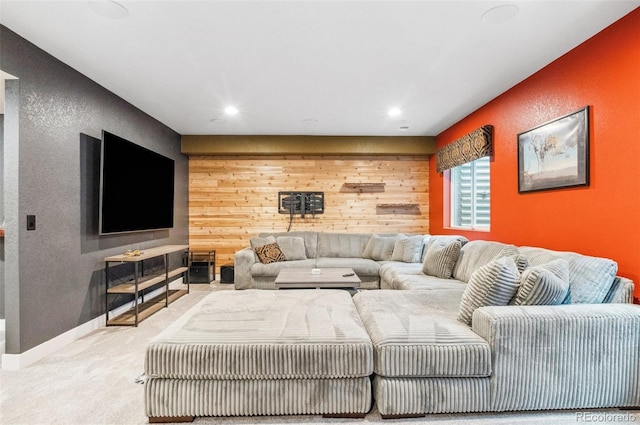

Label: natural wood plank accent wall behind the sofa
[189,155,429,273]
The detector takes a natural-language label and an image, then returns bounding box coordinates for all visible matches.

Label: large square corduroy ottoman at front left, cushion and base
[145,289,373,422]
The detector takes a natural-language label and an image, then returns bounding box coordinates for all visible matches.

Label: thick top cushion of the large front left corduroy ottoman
[145,289,373,379]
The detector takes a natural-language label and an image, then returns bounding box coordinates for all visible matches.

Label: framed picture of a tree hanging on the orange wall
[518,106,589,193]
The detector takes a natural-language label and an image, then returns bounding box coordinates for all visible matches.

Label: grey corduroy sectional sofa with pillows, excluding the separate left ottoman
[235,232,640,417]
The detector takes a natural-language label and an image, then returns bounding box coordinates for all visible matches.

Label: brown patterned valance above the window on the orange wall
[436,125,493,173]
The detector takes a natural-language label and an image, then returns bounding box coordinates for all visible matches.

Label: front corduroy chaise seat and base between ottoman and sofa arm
[353,285,491,419]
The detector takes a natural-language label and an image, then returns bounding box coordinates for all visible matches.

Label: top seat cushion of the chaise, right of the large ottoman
[353,288,491,377]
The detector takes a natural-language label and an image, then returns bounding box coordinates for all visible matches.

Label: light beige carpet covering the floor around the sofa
[0,284,640,425]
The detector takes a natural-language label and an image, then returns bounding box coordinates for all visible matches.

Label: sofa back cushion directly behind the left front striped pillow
[453,241,518,282]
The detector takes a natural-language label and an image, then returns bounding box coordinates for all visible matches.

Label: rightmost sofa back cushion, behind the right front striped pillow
[518,246,618,304]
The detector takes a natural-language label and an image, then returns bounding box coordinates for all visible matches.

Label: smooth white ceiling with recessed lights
[0,0,640,136]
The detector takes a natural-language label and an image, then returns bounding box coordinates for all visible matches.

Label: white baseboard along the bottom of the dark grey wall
[2,278,182,370]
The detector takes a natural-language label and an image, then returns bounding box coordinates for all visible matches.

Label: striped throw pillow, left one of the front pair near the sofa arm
[458,257,520,325]
